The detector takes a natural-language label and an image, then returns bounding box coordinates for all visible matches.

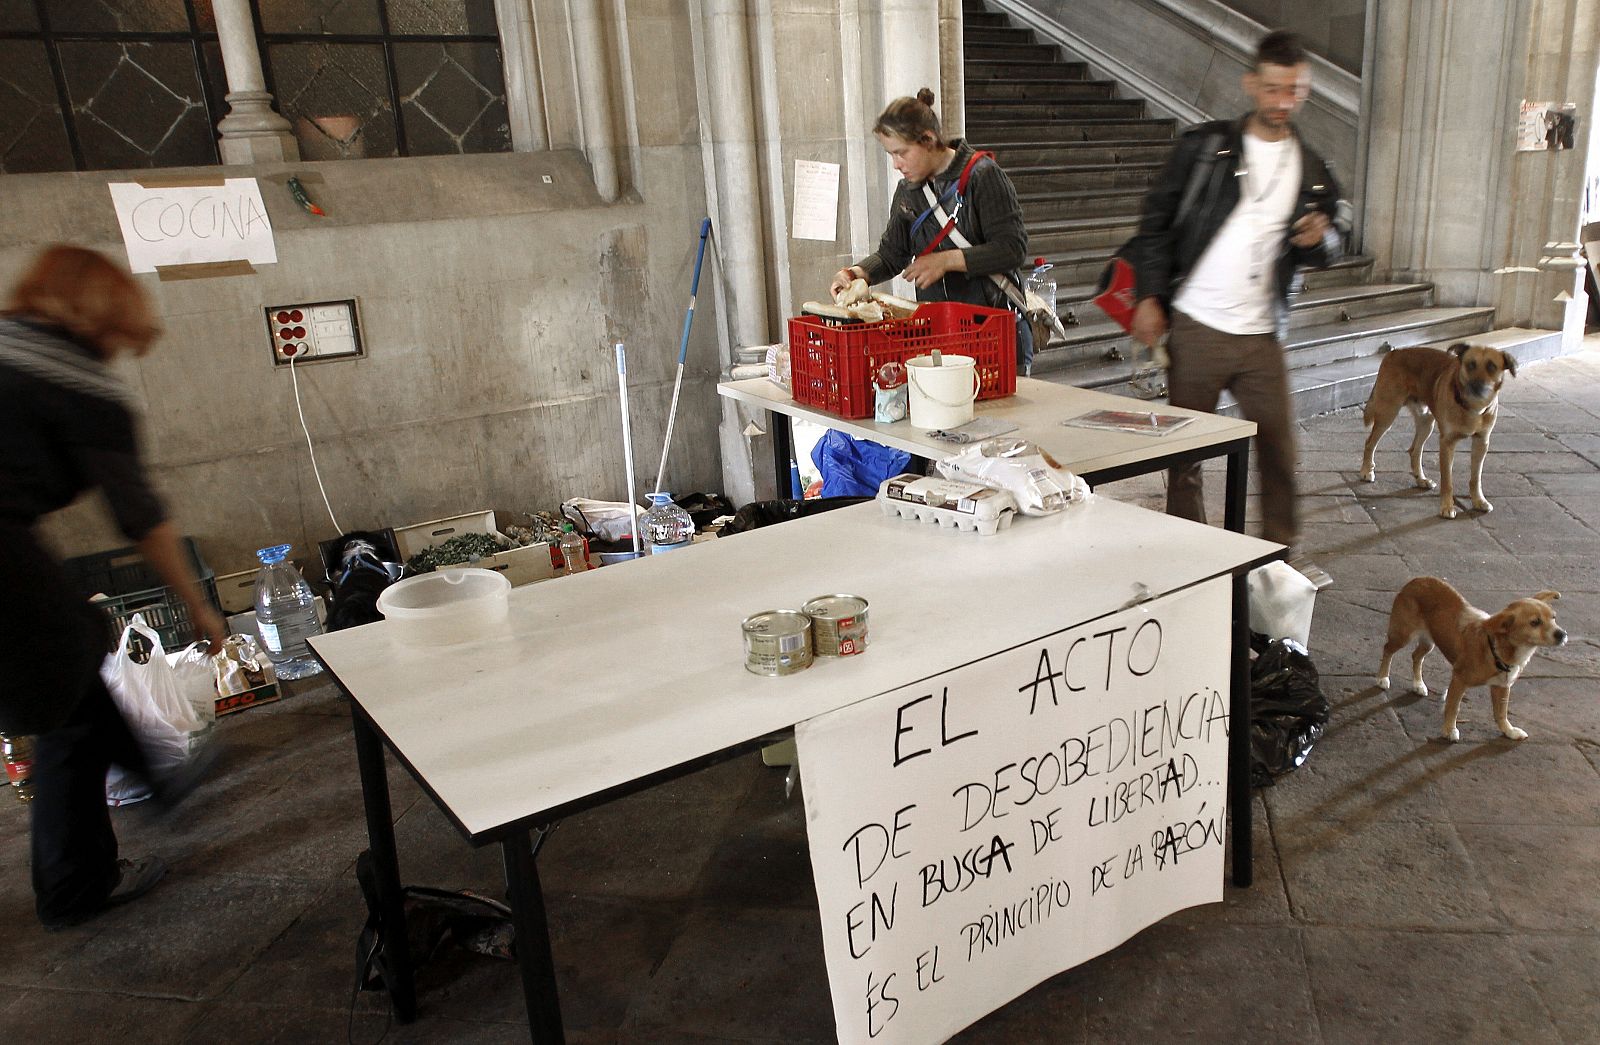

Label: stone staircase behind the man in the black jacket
[963,0,1560,416]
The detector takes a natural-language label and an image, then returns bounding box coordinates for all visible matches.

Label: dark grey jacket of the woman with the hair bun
[859,138,1027,309]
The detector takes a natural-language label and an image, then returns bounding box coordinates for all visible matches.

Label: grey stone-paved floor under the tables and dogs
[0,339,1600,1045]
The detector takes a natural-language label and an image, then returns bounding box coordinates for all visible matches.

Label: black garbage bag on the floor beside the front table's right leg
[1250,634,1330,787]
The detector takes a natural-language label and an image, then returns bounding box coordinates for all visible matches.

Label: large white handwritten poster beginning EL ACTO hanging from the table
[795,578,1230,1045]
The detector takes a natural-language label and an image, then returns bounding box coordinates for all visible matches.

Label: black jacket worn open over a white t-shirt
[1122,117,1349,330]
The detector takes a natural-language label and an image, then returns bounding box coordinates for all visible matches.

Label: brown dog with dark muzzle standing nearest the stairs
[1362,342,1517,518]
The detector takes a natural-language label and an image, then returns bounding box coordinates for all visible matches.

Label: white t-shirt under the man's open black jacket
[1173,133,1301,334]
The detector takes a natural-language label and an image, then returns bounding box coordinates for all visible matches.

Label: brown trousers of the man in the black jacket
[1166,312,1299,544]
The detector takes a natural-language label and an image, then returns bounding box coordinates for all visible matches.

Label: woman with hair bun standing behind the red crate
[832,88,1034,373]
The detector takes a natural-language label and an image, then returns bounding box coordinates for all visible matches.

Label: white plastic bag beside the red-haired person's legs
[101,613,216,773]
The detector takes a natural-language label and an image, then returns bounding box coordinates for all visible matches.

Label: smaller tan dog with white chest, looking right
[1378,578,1566,741]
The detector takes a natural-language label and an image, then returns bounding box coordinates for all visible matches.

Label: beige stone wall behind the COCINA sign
[0,3,722,573]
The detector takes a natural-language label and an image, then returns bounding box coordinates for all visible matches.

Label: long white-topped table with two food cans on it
[312,498,1280,1042]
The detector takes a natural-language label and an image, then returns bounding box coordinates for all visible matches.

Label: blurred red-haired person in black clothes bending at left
[0,246,224,928]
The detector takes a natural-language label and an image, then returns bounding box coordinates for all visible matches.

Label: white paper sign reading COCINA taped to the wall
[107,178,278,272]
